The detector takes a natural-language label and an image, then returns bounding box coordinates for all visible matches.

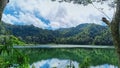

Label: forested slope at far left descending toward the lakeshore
[0,22,24,46]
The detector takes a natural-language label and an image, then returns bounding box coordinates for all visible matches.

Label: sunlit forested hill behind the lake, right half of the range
[57,24,112,45]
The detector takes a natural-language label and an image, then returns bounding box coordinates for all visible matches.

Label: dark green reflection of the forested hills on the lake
[27,48,117,67]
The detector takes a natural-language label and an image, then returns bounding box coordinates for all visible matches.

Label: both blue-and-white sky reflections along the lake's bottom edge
[30,58,118,68]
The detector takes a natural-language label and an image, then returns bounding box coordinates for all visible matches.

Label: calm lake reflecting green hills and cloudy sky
[16,46,117,68]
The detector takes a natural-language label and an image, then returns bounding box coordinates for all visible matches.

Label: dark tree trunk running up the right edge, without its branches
[110,0,120,68]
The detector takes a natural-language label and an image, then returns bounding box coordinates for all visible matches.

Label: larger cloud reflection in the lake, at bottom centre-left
[30,59,79,68]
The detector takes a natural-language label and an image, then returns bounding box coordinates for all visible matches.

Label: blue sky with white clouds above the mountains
[2,0,115,30]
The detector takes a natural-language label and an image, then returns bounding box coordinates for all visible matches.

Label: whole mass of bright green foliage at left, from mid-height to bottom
[0,35,29,68]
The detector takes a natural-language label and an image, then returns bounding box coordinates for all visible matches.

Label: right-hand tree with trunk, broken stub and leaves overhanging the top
[52,0,120,68]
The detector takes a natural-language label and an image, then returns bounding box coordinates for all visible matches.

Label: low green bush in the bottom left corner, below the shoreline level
[0,50,29,68]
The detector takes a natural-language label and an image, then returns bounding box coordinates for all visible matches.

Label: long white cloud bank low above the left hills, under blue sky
[2,12,48,29]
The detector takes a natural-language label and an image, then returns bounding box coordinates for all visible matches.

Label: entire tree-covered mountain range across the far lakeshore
[6,24,113,45]
